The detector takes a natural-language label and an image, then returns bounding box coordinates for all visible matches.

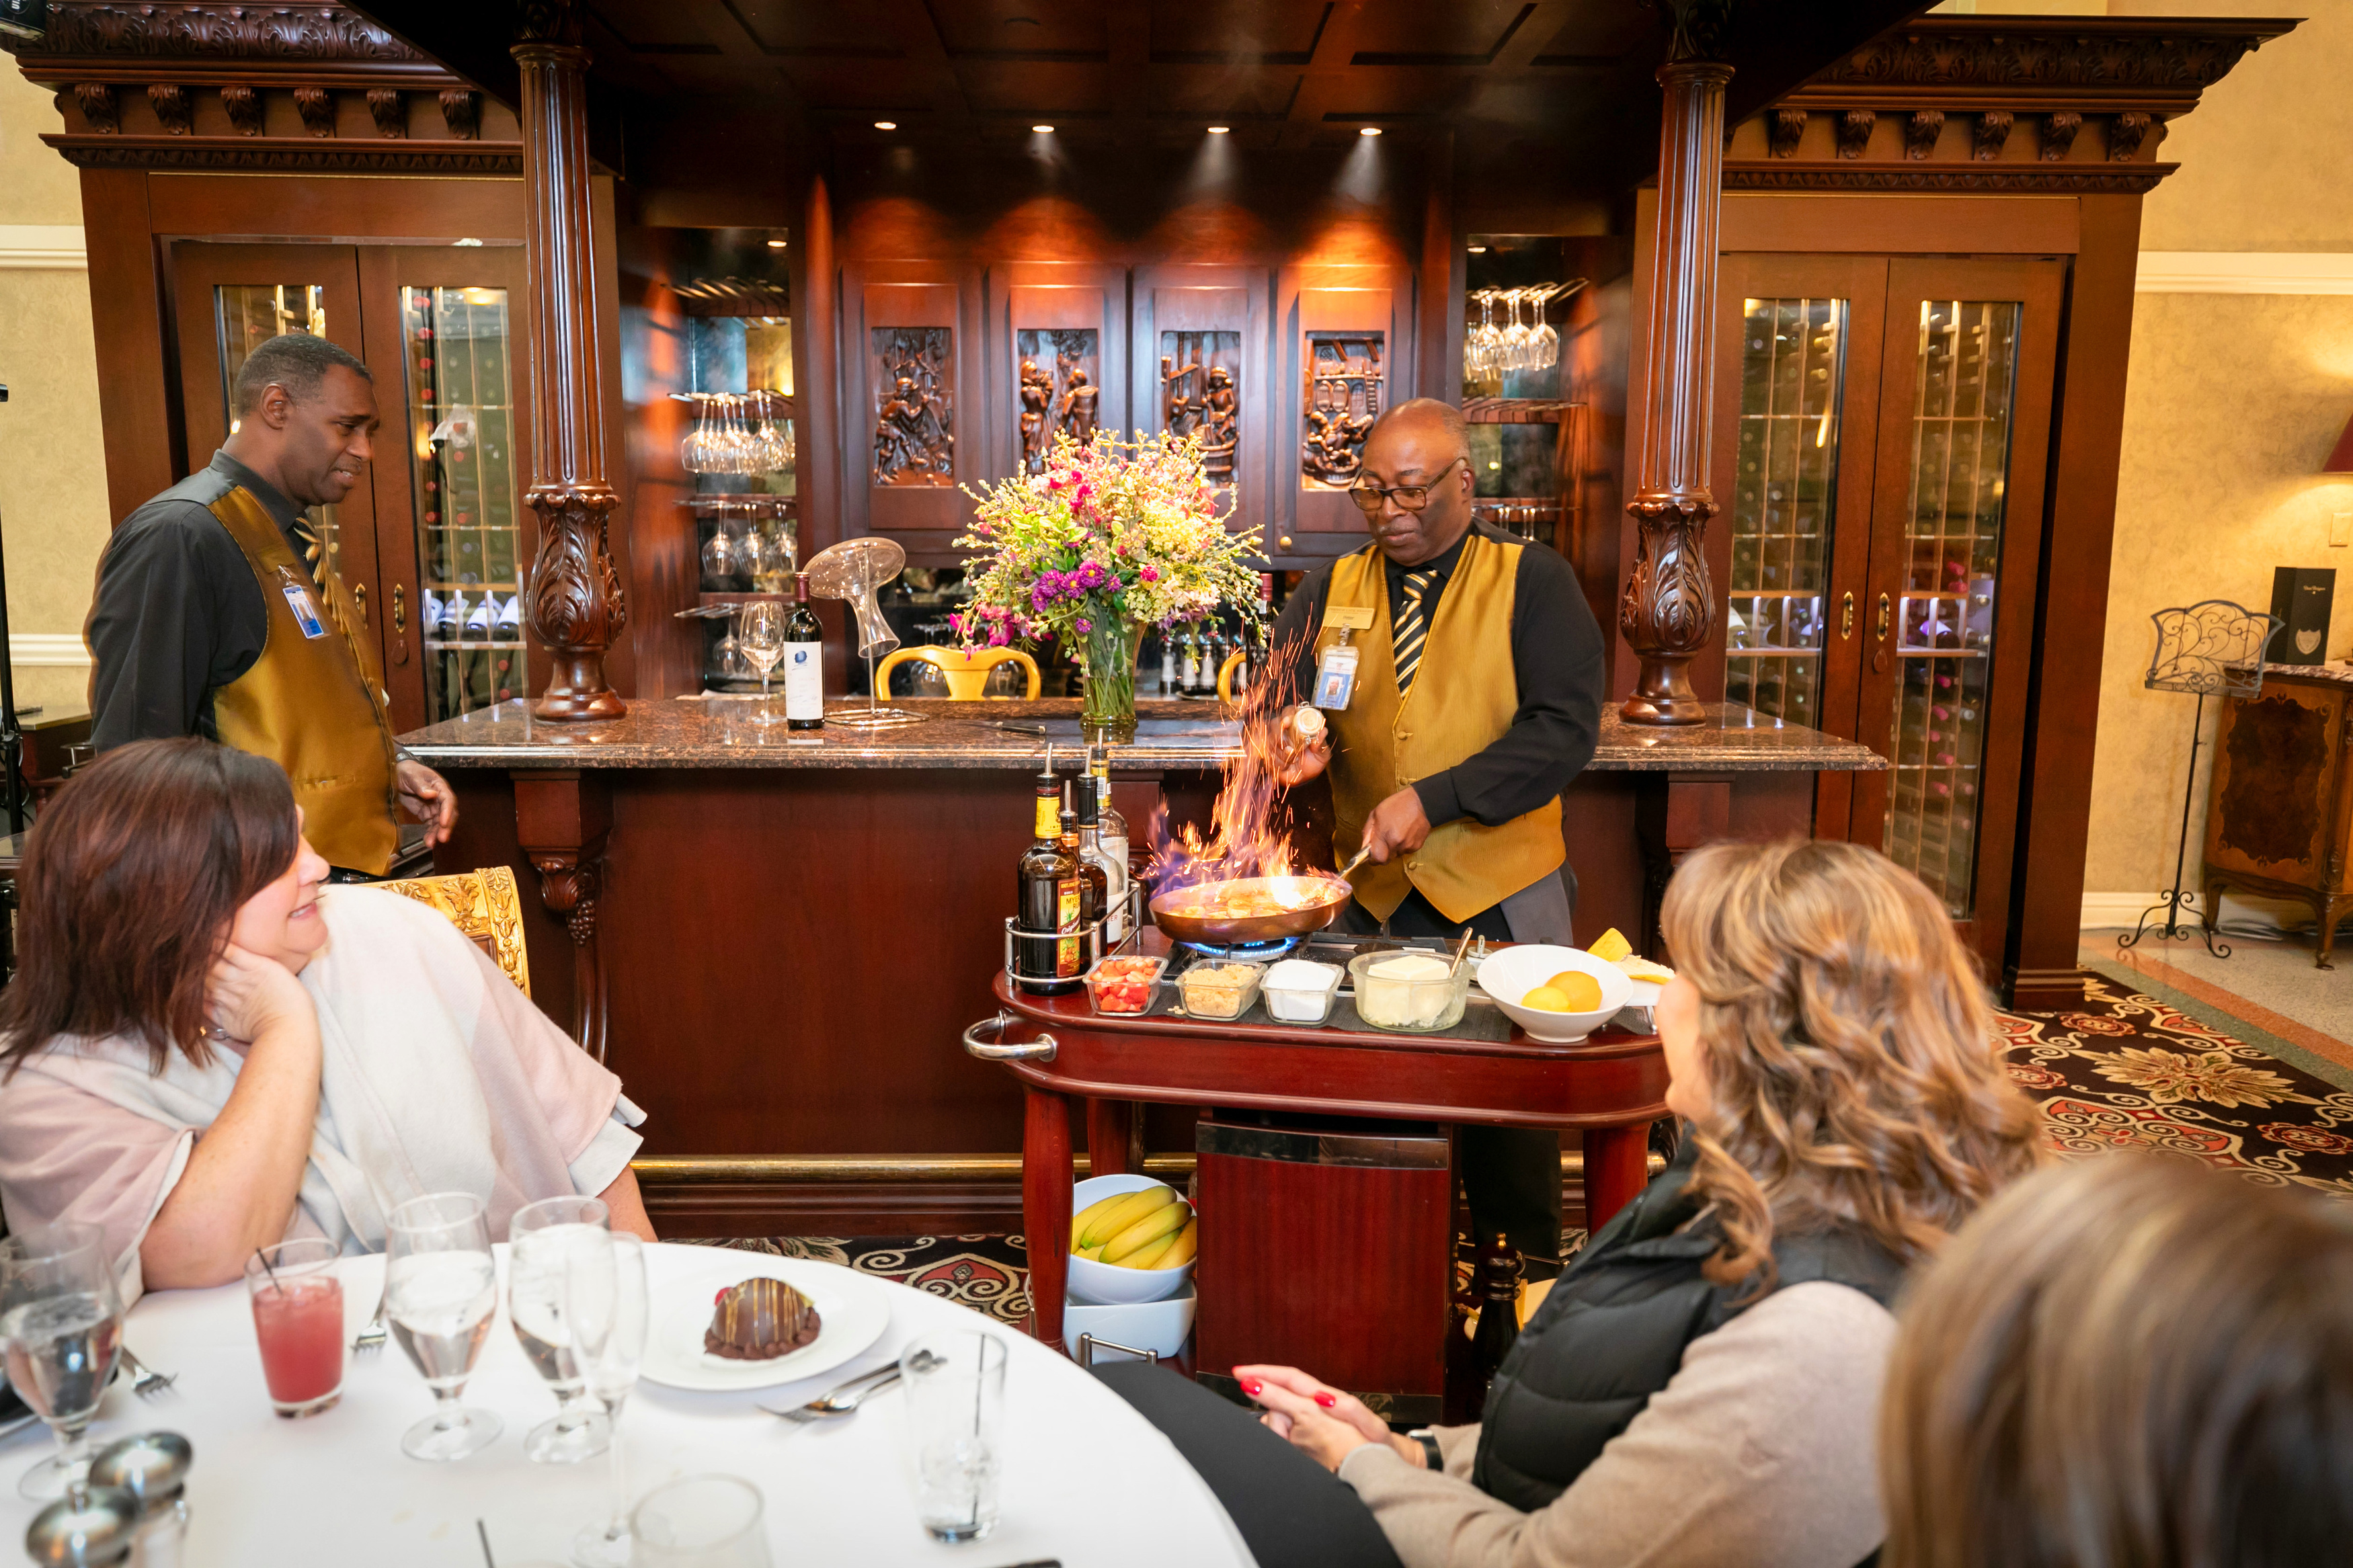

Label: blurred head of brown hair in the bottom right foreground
[1880,1154,2353,1568]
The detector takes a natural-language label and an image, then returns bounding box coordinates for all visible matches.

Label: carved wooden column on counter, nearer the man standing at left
[513,0,629,719]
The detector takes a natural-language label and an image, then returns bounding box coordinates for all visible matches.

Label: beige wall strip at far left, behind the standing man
[0,61,111,712]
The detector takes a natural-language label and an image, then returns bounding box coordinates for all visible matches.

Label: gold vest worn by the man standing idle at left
[212,487,400,877]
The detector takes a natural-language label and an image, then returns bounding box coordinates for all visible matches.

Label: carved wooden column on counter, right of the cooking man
[1619,17,1732,724]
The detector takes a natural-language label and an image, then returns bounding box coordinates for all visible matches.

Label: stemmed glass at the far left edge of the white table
[0,1223,122,1502]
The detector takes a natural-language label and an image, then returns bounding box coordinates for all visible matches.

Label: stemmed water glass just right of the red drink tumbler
[384,1192,506,1462]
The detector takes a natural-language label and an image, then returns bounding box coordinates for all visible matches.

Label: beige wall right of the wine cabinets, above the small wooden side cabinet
[2080,0,2353,921]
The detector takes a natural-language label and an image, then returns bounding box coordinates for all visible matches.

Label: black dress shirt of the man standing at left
[85,452,313,750]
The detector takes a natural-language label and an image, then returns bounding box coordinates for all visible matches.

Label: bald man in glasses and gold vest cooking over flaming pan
[1271,397,1603,1274]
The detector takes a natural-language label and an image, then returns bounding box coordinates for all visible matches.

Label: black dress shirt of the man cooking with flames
[1269,522,1603,827]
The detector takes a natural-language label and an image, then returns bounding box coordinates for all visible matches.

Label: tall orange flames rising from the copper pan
[1144,620,1346,912]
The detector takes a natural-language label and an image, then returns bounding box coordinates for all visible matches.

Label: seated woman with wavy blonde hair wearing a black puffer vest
[1099,839,2038,1568]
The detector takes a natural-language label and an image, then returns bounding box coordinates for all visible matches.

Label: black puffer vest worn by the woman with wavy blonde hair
[1471,1138,1904,1512]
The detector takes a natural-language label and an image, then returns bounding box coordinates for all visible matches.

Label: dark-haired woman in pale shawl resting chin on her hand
[0,741,652,1298]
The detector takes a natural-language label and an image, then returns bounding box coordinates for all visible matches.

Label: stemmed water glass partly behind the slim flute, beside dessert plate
[506,1194,612,1464]
